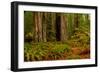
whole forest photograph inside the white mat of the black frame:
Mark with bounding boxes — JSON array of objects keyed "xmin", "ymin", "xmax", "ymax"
[{"xmin": 24, "ymin": 11, "xmax": 90, "ymax": 61}]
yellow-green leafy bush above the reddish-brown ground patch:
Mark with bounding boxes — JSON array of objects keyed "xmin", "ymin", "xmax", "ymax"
[{"xmin": 69, "ymin": 29, "xmax": 90, "ymax": 48}]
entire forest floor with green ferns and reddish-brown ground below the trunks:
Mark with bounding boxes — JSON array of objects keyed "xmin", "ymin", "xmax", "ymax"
[{"xmin": 24, "ymin": 42, "xmax": 90, "ymax": 61}]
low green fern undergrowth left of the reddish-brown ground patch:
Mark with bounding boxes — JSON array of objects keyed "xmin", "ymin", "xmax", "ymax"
[{"xmin": 24, "ymin": 42, "xmax": 70, "ymax": 61}]
